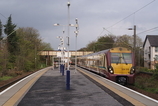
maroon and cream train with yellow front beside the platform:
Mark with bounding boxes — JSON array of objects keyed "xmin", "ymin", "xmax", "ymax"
[{"xmin": 78, "ymin": 47, "xmax": 135, "ymax": 85}]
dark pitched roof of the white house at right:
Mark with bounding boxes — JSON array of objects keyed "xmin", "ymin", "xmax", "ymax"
[{"xmin": 143, "ymin": 35, "xmax": 158, "ymax": 47}]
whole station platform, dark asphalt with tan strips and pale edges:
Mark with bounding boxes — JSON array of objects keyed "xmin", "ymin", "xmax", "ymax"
[{"xmin": 0, "ymin": 67, "xmax": 157, "ymax": 106}]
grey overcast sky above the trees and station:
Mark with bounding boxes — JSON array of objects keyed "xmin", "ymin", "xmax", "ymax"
[{"xmin": 0, "ymin": 0, "xmax": 158, "ymax": 50}]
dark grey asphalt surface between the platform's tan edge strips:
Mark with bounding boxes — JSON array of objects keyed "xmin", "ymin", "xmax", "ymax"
[{"xmin": 18, "ymin": 68, "xmax": 131, "ymax": 106}]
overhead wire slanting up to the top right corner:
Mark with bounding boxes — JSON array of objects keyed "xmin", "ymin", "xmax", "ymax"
[{"xmin": 106, "ymin": 0, "xmax": 155, "ymax": 29}]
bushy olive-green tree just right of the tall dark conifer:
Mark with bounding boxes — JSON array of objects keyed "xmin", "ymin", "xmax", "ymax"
[{"xmin": 16, "ymin": 27, "xmax": 52, "ymax": 71}]
